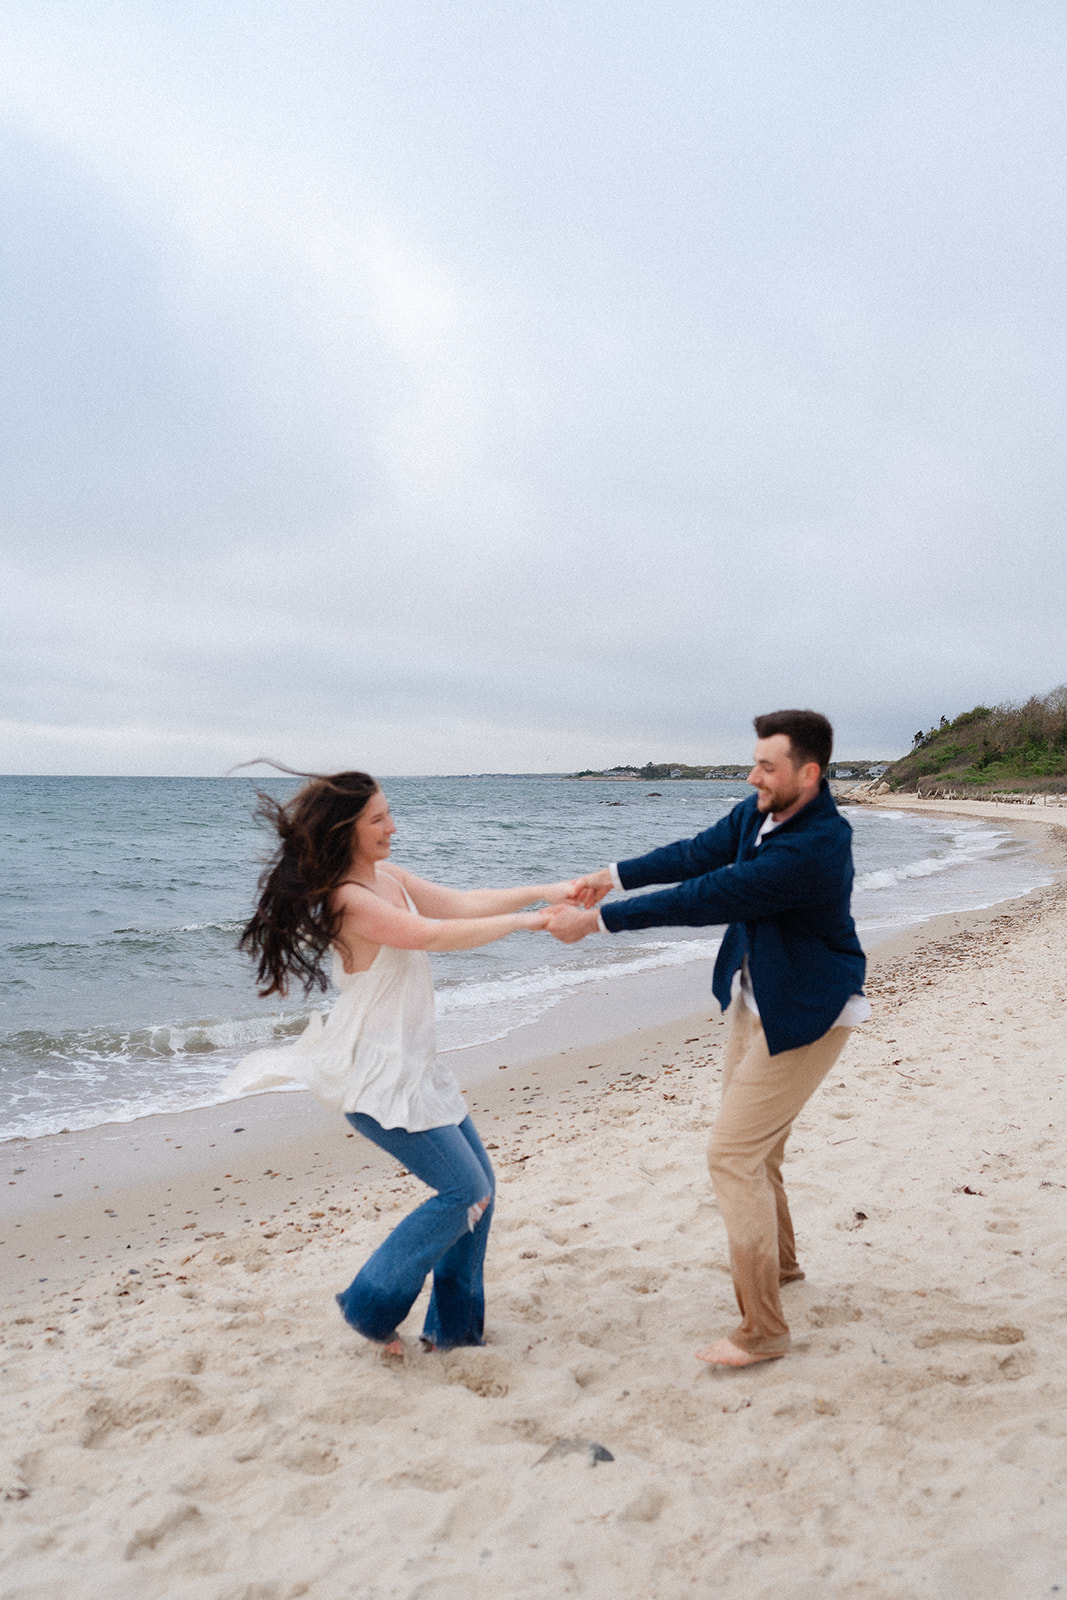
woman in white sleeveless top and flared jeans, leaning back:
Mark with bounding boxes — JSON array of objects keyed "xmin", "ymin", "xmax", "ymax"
[{"xmin": 227, "ymin": 773, "xmax": 573, "ymax": 1355}]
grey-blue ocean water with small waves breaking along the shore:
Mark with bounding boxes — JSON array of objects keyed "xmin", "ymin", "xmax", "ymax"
[{"xmin": 0, "ymin": 776, "xmax": 1051, "ymax": 1139}]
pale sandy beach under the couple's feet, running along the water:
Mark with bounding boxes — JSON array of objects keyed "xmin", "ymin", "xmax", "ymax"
[{"xmin": 0, "ymin": 798, "xmax": 1067, "ymax": 1600}]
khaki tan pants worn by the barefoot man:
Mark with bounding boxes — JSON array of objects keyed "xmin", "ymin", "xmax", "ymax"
[{"xmin": 707, "ymin": 995, "xmax": 851, "ymax": 1355}]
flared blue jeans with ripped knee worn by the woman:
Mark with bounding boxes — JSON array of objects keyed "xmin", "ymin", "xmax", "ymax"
[{"xmin": 338, "ymin": 1112, "xmax": 494, "ymax": 1350}]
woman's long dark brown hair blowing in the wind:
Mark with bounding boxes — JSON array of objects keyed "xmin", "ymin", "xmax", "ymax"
[{"xmin": 240, "ymin": 768, "xmax": 378, "ymax": 997}]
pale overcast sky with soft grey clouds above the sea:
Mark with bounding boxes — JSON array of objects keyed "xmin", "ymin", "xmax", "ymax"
[{"xmin": 0, "ymin": 0, "xmax": 1067, "ymax": 774}]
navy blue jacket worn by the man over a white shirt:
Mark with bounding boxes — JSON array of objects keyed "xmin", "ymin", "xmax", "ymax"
[{"xmin": 600, "ymin": 779, "xmax": 867, "ymax": 1056}]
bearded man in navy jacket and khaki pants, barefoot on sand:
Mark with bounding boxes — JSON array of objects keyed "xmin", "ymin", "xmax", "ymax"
[{"xmin": 549, "ymin": 710, "xmax": 870, "ymax": 1366}]
